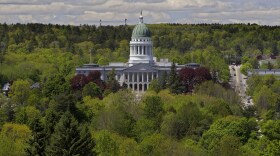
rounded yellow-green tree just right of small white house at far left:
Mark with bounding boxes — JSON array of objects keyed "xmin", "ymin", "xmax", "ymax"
[{"xmin": 11, "ymin": 80, "xmax": 30, "ymax": 105}]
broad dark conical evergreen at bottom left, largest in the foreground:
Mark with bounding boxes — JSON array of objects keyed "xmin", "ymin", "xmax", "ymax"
[{"xmin": 47, "ymin": 111, "xmax": 93, "ymax": 156}]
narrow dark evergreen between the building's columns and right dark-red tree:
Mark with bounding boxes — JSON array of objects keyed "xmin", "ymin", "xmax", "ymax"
[{"xmin": 168, "ymin": 62, "xmax": 180, "ymax": 94}]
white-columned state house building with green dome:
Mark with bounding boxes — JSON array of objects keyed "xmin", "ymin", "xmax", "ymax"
[{"xmin": 76, "ymin": 14, "xmax": 199, "ymax": 92}]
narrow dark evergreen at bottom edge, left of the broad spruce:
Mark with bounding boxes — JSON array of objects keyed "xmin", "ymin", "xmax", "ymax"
[{"xmin": 25, "ymin": 118, "xmax": 46, "ymax": 156}]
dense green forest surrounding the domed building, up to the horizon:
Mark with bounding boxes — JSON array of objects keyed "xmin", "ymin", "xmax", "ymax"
[{"xmin": 0, "ymin": 24, "xmax": 280, "ymax": 156}]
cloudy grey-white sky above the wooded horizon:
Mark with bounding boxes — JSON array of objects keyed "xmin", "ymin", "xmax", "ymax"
[{"xmin": 0, "ymin": 0, "xmax": 280, "ymax": 25}]
